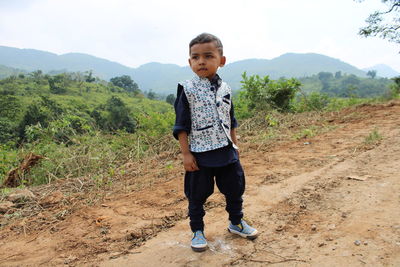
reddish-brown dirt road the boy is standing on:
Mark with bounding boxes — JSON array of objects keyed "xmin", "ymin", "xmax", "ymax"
[{"xmin": 0, "ymin": 102, "xmax": 400, "ymax": 266}]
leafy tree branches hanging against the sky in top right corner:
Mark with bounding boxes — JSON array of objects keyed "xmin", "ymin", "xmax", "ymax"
[{"xmin": 358, "ymin": 0, "xmax": 400, "ymax": 44}]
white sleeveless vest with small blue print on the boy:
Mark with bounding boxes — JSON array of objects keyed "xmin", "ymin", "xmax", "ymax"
[{"xmin": 181, "ymin": 76, "xmax": 237, "ymax": 152}]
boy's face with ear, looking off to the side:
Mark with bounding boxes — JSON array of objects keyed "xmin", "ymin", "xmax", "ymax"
[{"xmin": 189, "ymin": 42, "xmax": 226, "ymax": 79}]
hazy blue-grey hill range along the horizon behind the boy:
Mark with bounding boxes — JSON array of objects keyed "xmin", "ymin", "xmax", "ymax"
[{"xmin": 0, "ymin": 46, "xmax": 368, "ymax": 94}]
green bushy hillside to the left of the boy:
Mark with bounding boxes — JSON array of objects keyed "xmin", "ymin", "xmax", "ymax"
[{"xmin": 0, "ymin": 71, "xmax": 174, "ymax": 184}]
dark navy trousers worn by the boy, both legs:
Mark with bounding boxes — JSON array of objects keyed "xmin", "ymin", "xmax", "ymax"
[{"xmin": 185, "ymin": 161, "xmax": 245, "ymax": 232}]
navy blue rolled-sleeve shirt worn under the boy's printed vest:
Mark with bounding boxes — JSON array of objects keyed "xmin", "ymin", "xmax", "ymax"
[{"xmin": 173, "ymin": 74, "xmax": 239, "ymax": 167}]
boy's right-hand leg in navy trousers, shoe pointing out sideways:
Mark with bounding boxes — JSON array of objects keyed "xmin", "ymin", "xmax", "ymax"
[{"xmin": 216, "ymin": 161, "xmax": 246, "ymax": 224}]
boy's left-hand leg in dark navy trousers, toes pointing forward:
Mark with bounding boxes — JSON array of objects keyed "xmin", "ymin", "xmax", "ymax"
[{"xmin": 185, "ymin": 166, "xmax": 214, "ymax": 232}]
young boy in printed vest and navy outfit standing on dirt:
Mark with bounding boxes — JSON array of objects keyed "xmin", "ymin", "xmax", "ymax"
[{"xmin": 173, "ymin": 33, "xmax": 257, "ymax": 251}]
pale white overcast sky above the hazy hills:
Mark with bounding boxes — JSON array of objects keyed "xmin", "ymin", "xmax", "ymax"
[{"xmin": 0, "ymin": 0, "xmax": 400, "ymax": 72}]
